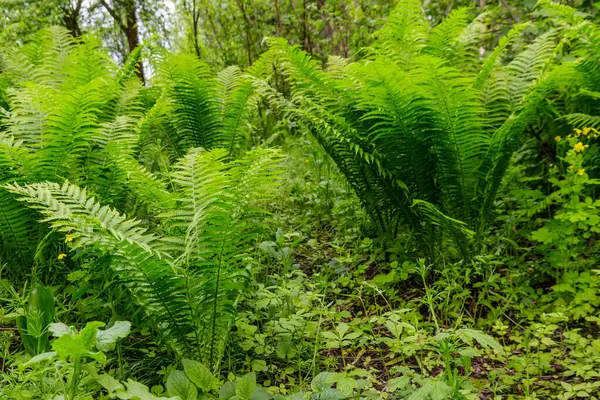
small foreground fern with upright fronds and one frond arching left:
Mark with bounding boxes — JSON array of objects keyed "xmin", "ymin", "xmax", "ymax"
[{"xmin": 6, "ymin": 149, "xmax": 280, "ymax": 368}]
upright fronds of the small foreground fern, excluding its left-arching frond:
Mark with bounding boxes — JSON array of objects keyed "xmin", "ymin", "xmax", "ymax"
[{"xmin": 164, "ymin": 149, "xmax": 280, "ymax": 366}]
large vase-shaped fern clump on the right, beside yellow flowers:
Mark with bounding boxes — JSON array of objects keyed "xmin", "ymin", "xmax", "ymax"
[{"xmin": 255, "ymin": 0, "xmax": 562, "ymax": 258}]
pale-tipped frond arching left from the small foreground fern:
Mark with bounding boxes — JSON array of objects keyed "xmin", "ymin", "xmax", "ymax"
[{"xmin": 5, "ymin": 182, "xmax": 193, "ymax": 350}]
